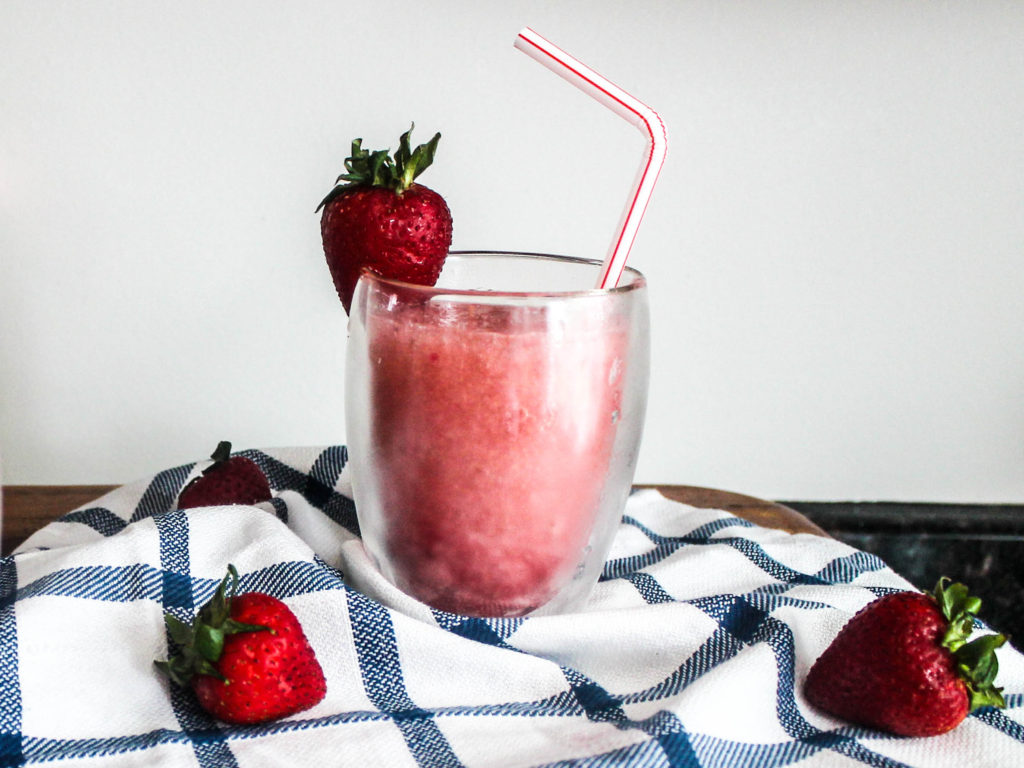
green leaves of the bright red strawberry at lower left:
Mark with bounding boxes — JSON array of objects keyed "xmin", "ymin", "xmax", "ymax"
[{"xmin": 154, "ymin": 565, "xmax": 272, "ymax": 685}]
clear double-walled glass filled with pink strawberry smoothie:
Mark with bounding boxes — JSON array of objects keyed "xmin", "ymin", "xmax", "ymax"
[{"xmin": 346, "ymin": 252, "xmax": 649, "ymax": 616}]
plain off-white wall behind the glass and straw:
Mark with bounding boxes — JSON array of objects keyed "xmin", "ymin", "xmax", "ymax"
[{"xmin": 0, "ymin": 0, "xmax": 1024, "ymax": 503}]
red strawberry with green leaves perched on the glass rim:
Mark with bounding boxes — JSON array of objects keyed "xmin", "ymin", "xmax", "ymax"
[{"xmin": 316, "ymin": 123, "xmax": 452, "ymax": 312}]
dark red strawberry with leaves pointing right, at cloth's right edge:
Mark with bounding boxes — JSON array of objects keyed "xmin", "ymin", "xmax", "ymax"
[{"xmin": 804, "ymin": 577, "xmax": 1007, "ymax": 736}]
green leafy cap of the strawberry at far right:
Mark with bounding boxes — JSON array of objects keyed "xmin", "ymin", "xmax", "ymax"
[{"xmin": 932, "ymin": 577, "xmax": 1007, "ymax": 712}]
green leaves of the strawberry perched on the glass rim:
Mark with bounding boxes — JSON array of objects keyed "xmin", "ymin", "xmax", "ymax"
[{"xmin": 316, "ymin": 123, "xmax": 441, "ymax": 211}]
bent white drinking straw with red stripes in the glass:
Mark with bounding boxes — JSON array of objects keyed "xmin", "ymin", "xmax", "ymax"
[{"xmin": 515, "ymin": 27, "xmax": 668, "ymax": 288}]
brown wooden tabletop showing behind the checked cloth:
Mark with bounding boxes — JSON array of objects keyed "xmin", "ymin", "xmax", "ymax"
[{"xmin": 0, "ymin": 485, "xmax": 827, "ymax": 555}]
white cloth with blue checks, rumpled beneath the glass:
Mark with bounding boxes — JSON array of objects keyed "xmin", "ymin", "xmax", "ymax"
[{"xmin": 0, "ymin": 446, "xmax": 1024, "ymax": 768}]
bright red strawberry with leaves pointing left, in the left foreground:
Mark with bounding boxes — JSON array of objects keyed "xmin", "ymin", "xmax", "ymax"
[{"xmin": 156, "ymin": 565, "xmax": 327, "ymax": 723}]
